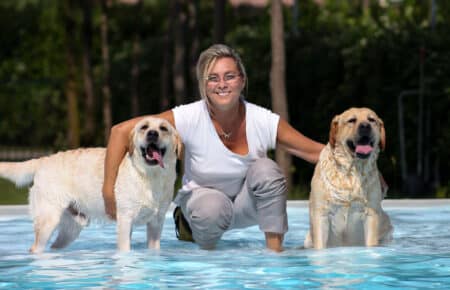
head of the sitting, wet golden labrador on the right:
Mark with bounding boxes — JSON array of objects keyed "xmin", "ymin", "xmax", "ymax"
[{"xmin": 329, "ymin": 108, "xmax": 386, "ymax": 159}]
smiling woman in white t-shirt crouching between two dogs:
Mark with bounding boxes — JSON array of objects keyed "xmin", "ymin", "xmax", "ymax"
[{"xmin": 103, "ymin": 44, "xmax": 323, "ymax": 251}]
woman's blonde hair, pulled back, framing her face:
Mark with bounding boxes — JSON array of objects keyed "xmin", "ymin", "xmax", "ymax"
[{"xmin": 197, "ymin": 44, "xmax": 247, "ymax": 106}]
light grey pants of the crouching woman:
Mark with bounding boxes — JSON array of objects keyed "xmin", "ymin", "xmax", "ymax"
[{"xmin": 177, "ymin": 158, "xmax": 288, "ymax": 249}]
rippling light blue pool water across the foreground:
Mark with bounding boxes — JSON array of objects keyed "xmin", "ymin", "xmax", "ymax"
[{"xmin": 0, "ymin": 206, "xmax": 450, "ymax": 289}]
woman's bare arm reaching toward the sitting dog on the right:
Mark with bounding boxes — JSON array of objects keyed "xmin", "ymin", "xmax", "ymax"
[{"xmin": 277, "ymin": 118, "xmax": 325, "ymax": 163}]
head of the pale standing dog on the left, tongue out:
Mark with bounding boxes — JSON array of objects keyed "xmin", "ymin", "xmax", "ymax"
[{"xmin": 128, "ymin": 117, "xmax": 183, "ymax": 168}]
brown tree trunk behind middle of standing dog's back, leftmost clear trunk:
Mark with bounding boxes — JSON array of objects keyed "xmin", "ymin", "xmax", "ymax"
[{"xmin": 63, "ymin": 0, "xmax": 80, "ymax": 148}]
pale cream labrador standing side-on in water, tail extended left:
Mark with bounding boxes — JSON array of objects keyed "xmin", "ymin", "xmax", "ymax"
[{"xmin": 0, "ymin": 117, "xmax": 182, "ymax": 253}]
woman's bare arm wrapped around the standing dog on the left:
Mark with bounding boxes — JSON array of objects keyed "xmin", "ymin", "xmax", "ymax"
[{"xmin": 102, "ymin": 110, "xmax": 175, "ymax": 220}]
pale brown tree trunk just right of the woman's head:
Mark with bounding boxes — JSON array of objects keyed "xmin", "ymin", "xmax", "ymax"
[{"xmin": 270, "ymin": 0, "xmax": 292, "ymax": 189}]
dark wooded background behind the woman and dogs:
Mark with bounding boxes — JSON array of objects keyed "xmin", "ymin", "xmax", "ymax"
[{"xmin": 0, "ymin": 0, "xmax": 450, "ymax": 204}]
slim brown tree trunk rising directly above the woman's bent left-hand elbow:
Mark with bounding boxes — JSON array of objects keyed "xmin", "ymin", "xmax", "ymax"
[{"xmin": 100, "ymin": 0, "xmax": 112, "ymax": 144}]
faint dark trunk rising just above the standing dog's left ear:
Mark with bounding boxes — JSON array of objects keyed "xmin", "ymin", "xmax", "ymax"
[{"xmin": 131, "ymin": 0, "xmax": 142, "ymax": 117}]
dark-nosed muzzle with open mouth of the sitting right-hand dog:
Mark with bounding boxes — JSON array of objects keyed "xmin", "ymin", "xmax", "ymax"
[{"xmin": 347, "ymin": 122, "xmax": 374, "ymax": 159}]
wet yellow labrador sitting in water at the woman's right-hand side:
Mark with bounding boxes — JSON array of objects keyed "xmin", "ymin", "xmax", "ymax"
[{"xmin": 304, "ymin": 108, "xmax": 392, "ymax": 249}]
